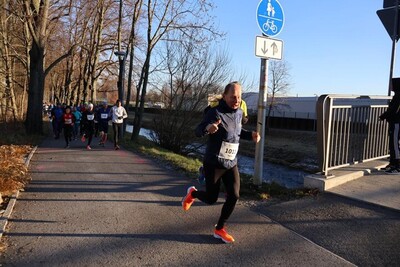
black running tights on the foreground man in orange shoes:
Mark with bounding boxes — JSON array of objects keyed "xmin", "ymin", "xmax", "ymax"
[{"xmin": 192, "ymin": 164, "xmax": 240, "ymax": 229}]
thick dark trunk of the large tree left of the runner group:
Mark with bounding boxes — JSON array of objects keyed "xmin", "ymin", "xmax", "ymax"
[{"xmin": 25, "ymin": 42, "xmax": 45, "ymax": 134}]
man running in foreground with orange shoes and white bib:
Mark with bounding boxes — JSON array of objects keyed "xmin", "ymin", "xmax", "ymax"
[{"xmin": 182, "ymin": 82, "xmax": 260, "ymax": 243}]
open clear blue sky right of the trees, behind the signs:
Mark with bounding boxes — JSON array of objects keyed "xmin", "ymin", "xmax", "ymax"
[{"xmin": 214, "ymin": 0, "xmax": 394, "ymax": 96}]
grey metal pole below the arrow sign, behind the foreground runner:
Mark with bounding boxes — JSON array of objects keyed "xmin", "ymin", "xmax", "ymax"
[{"xmin": 253, "ymin": 58, "xmax": 268, "ymax": 185}]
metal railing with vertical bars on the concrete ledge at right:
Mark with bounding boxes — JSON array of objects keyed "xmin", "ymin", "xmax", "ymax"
[{"xmin": 316, "ymin": 95, "xmax": 391, "ymax": 177}]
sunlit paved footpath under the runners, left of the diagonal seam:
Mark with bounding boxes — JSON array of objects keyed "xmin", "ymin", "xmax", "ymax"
[{"xmin": 0, "ymin": 139, "xmax": 352, "ymax": 266}]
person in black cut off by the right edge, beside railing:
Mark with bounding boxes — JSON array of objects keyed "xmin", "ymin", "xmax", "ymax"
[{"xmin": 379, "ymin": 78, "xmax": 400, "ymax": 174}]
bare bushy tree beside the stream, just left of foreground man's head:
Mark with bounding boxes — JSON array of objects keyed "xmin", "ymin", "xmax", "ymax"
[{"xmin": 154, "ymin": 34, "xmax": 230, "ymax": 153}]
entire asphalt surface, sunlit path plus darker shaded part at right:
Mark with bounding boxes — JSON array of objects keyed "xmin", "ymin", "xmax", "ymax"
[{"xmin": 0, "ymin": 139, "xmax": 400, "ymax": 266}]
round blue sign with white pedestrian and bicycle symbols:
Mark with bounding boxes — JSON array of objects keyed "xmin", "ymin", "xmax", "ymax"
[{"xmin": 257, "ymin": 0, "xmax": 285, "ymax": 37}]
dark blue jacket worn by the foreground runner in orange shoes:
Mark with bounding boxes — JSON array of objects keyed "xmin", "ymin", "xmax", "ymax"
[{"xmin": 196, "ymin": 100, "xmax": 252, "ymax": 169}]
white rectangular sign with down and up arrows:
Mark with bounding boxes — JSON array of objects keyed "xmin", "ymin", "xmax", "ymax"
[{"xmin": 256, "ymin": 36, "xmax": 283, "ymax": 59}]
